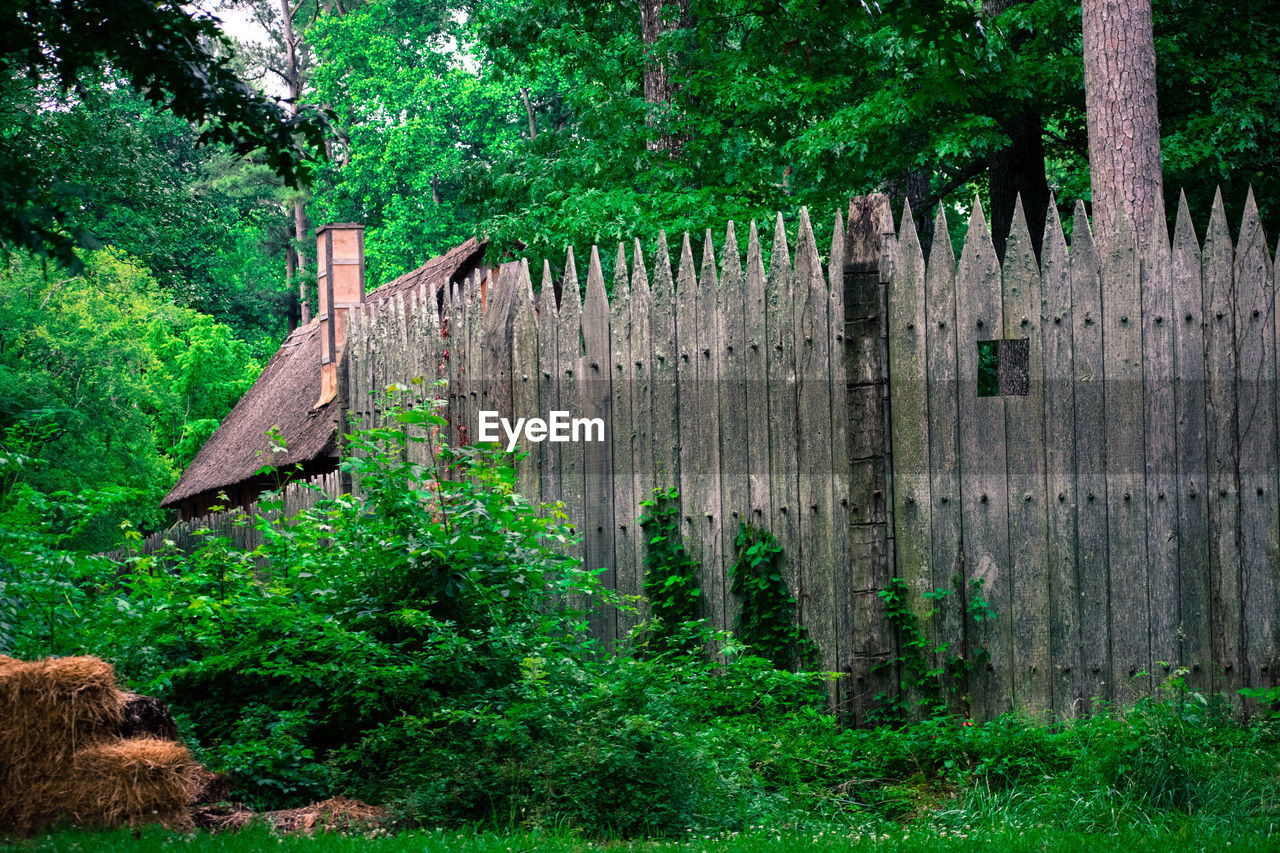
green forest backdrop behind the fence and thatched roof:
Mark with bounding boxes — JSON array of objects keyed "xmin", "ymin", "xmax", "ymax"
[{"xmin": 0, "ymin": 0, "xmax": 1280, "ymax": 546}]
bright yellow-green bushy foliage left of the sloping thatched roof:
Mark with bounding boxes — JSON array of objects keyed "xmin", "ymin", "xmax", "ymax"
[{"xmin": 0, "ymin": 251, "xmax": 260, "ymax": 547}]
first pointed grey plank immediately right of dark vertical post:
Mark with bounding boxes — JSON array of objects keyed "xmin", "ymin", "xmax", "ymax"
[{"xmin": 888, "ymin": 202, "xmax": 937, "ymax": 712}]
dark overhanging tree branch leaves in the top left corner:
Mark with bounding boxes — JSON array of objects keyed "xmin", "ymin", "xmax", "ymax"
[{"xmin": 0, "ymin": 0, "xmax": 326, "ymax": 272}]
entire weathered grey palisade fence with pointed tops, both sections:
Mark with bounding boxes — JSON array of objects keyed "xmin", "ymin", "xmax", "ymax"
[{"xmin": 343, "ymin": 185, "xmax": 1280, "ymax": 720}]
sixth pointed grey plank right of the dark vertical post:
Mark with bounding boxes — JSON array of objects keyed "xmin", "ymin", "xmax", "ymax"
[{"xmin": 1071, "ymin": 202, "xmax": 1111, "ymax": 707}]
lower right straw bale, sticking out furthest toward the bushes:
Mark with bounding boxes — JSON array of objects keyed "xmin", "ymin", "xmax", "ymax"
[{"xmin": 64, "ymin": 738, "xmax": 211, "ymax": 829}]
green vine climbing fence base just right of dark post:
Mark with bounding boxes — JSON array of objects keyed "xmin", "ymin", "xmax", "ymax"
[{"xmin": 877, "ymin": 578, "xmax": 997, "ymax": 719}]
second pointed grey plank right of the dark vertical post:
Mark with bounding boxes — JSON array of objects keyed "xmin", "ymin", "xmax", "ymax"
[{"xmin": 924, "ymin": 205, "xmax": 965, "ymax": 711}]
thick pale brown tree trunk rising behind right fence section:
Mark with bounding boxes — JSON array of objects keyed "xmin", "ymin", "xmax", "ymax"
[{"xmin": 1082, "ymin": 0, "xmax": 1165, "ymax": 247}]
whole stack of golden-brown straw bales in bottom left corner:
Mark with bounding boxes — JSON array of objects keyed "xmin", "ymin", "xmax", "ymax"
[{"xmin": 0, "ymin": 656, "xmax": 210, "ymax": 834}]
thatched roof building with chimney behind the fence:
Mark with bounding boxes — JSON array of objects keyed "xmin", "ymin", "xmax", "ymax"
[{"xmin": 161, "ymin": 224, "xmax": 485, "ymax": 519}]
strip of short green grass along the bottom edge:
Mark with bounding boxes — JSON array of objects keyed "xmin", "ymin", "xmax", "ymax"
[{"xmin": 13, "ymin": 827, "xmax": 1280, "ymax": 853}]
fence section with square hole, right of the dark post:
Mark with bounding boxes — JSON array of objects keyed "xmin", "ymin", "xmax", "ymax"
[{"xmin": 888, "ymin": 188, "xmax": 1280, "ymax": 716}]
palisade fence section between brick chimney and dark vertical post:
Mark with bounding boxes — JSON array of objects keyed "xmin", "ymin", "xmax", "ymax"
[{"xmin": 344, "ymin": 204, "xmax": 892, "ymax": 707}]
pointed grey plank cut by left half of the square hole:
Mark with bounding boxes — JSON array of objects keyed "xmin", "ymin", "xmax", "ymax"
[{"xmin": 962, "ymin": 202, "xmax": 1012, "ymax": 717}]
